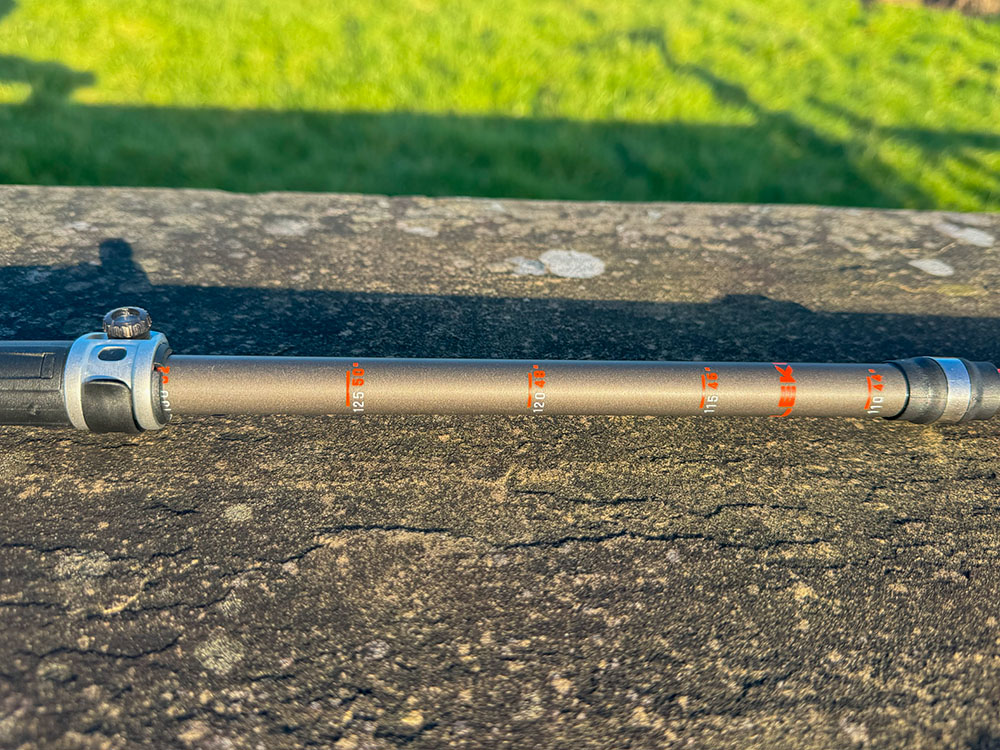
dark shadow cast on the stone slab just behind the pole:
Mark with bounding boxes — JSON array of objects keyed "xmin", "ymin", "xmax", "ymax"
[{"xmin": 0, "ymin": 238, "xmax": 997, "ymax": 362}]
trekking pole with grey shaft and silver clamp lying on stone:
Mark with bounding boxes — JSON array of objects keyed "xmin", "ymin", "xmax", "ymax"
[{"xmin": 0, "ymin": 307, "xmax": 1000, "ymax": 433}]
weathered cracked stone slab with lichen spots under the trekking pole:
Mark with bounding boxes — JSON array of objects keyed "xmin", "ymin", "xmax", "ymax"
[{"xmin": 0, "ymin": 187, "xmax": 1000, "ymax": 750}]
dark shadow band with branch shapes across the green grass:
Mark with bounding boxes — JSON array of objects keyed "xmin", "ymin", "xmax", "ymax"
[{"xmin": 0, "ymin": 0, "xmax": 1000, "ymax": 208}]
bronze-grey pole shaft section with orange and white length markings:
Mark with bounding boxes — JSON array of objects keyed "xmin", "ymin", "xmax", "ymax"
[{"xmin": 165, "ymin": 355, "xmax": 908, "ymax": 417}]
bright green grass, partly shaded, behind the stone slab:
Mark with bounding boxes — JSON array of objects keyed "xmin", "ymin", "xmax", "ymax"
[{"xmin": 0, "ymin": 0, "xmax": 1000, "ymax": 210}]
